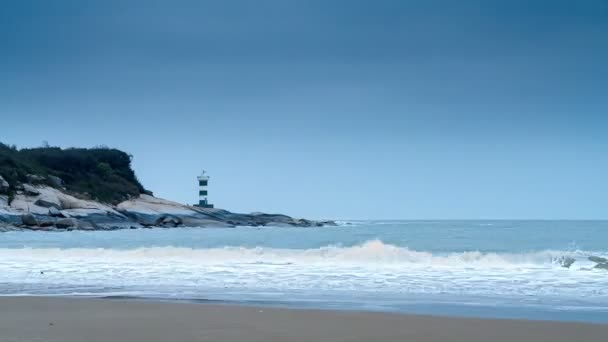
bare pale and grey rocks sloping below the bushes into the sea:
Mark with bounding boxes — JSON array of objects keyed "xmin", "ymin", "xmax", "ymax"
[{"xmin": 0, "ymin": 184, "xmax": 335, "ymax": 231}]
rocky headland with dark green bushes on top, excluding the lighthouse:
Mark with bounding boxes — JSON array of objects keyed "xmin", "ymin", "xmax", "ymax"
[{"xmin": 0, "ymin": 144, "xmax": 335, "ymax": 232}]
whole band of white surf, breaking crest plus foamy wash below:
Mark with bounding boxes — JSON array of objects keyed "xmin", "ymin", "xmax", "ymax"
[{"xmin": 0, "ymin": 240, "xmax": 608, "ymax": 305}]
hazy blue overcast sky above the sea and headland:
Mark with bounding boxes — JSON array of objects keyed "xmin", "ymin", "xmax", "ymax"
[{"xmin": 0, "ymin": 0, "xmax": 608, "ymax": 219}]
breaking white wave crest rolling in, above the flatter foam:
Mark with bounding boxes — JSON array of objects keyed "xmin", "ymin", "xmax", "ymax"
[{"xmin": 0, "ymin": 240, "xmax": 606, "ymax": 268}]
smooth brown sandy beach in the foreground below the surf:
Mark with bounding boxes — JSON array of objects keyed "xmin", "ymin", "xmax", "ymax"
[{"xmin": 0, "ymin": 297, "xmax": 608, "ymax": 342}]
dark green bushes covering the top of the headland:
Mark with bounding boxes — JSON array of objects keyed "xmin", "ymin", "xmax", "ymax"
[{"xmin": 0, "ymin": 143, "xmax": 146, "ymax": 204}]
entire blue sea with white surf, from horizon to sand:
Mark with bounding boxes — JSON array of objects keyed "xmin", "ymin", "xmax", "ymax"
[{"xmin": 0, "ymin": 221, "xmax": 608, "ymax": 322}]
